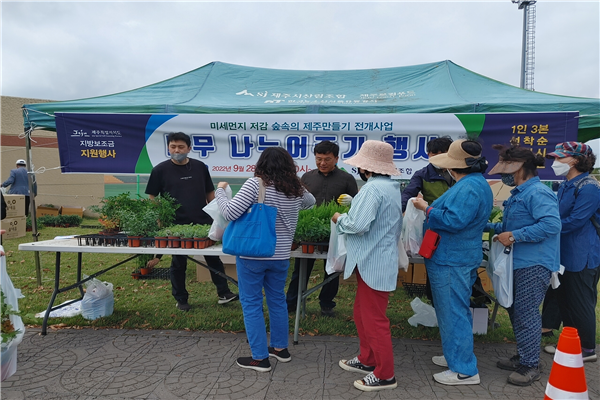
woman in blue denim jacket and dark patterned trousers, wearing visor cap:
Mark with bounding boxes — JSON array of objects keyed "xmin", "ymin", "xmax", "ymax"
[{"xmin": 486, "ymin": 145, "xmax": 561, "ymax": 386}]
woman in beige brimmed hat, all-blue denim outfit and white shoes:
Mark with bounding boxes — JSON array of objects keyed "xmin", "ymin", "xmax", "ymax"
[{"xmin": 414, "ymin": 139, "xmax": 493, "ymax": 386}]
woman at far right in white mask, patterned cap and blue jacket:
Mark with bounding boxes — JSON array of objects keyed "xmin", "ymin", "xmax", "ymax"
[{"xmin": 547, "ymin": 142, "xmax": 600, "ymax": 362}]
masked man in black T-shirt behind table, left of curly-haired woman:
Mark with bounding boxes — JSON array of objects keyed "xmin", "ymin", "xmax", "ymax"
[{"xmin": 146, "ymin": 132, "xmax": 238, "ymax": 311}]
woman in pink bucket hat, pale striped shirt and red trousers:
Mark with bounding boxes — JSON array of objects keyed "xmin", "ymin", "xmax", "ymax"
[{"xmin": 332, "ymin": 140, "xmax": 402, "ymax": 391}]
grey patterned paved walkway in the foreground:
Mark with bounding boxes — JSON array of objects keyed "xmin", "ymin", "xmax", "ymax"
[{"xmin": 1, "ymin": 328, "xmax": 600, "ymax": 400}]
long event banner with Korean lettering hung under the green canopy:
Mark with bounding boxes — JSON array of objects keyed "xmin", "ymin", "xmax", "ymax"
[{"xmin": 55, "ymin": 112, "xmax": 578, "ymax": 180}]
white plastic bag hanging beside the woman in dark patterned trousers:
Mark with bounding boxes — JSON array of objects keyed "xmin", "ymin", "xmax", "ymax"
[{"xmin": 488, "ymin": 240, "xmax": 513, "ymax": 307}]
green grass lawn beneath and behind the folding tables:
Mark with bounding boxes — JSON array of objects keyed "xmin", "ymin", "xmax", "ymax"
[{"xmin": 3, "ymin": 219, "xmax": 600, "ymax": 344}]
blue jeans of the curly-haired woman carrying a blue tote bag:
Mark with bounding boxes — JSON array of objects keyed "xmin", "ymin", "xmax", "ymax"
[{"xmin": 236, "ymin": 257, "xmax": 290, "ymax": 360}]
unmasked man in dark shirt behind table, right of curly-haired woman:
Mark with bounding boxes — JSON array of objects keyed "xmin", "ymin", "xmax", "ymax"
[{"xmin": 286, "ymin": 140, "xmax": 358, "ymax": 317}]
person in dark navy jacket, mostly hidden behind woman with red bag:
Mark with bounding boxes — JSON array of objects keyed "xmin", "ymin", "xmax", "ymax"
[{"xmin": 402, "ymin": 136, "xmax": 456, "ymax": 213}]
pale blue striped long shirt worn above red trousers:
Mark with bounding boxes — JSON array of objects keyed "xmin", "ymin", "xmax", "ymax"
[{"xmin": 336, "ymin": 177, "xmax": 402, "ymax": 292}]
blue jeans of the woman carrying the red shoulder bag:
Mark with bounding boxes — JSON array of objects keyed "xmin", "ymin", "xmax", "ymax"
[{"xmin": 425, "ymin": 260, "xmax": 479, "ymax": 376}]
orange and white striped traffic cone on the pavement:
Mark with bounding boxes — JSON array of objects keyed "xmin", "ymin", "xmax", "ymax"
[{"xmin": 544, "ymin": 327, "xmax": 589, "ymax": 400}]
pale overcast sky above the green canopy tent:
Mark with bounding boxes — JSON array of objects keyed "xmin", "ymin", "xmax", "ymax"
[{"xmin": 1, "ymin": 0, "xmax": 600, "ymax": 150}]
